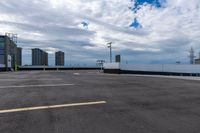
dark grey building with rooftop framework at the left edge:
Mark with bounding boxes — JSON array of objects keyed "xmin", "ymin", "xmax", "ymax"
[{"xmin": 0, "ymin": 35, "xmax": 21, "ymax": 71}]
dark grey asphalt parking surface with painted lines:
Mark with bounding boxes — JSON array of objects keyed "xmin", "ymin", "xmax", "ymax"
[{"xmin": 0, "ymin": 70, "xmax": 200, "ymax": 133}]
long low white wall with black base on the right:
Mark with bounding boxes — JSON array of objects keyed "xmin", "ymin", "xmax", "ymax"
[{"xmin": 104, "ymin": 63, "xmax": 200, "ymax": 76}]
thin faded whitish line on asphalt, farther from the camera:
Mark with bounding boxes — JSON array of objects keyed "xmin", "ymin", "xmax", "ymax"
[{"xmin": 0, "ymin": 84, "xmax": 74, "ymax": 89}]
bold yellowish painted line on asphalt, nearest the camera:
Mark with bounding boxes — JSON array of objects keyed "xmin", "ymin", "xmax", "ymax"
[{"xmin": 0, "ymin": 101, "xmax": 106, "ymax": 114}]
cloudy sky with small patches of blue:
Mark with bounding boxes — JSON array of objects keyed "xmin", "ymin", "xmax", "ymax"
[{"xmin": 0, "ymin": 0, "xmax": 200, "ymax": 65}]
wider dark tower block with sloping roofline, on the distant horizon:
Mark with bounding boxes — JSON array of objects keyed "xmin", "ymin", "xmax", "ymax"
[{"xmin": 32, "ymin": 48, "xmax": 48, "ymax": 66}]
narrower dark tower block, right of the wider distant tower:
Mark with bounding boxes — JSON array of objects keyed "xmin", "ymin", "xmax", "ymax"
[{"xmin": 55, "ymin": 51, "xmax": 65, "ymax": 66}]
